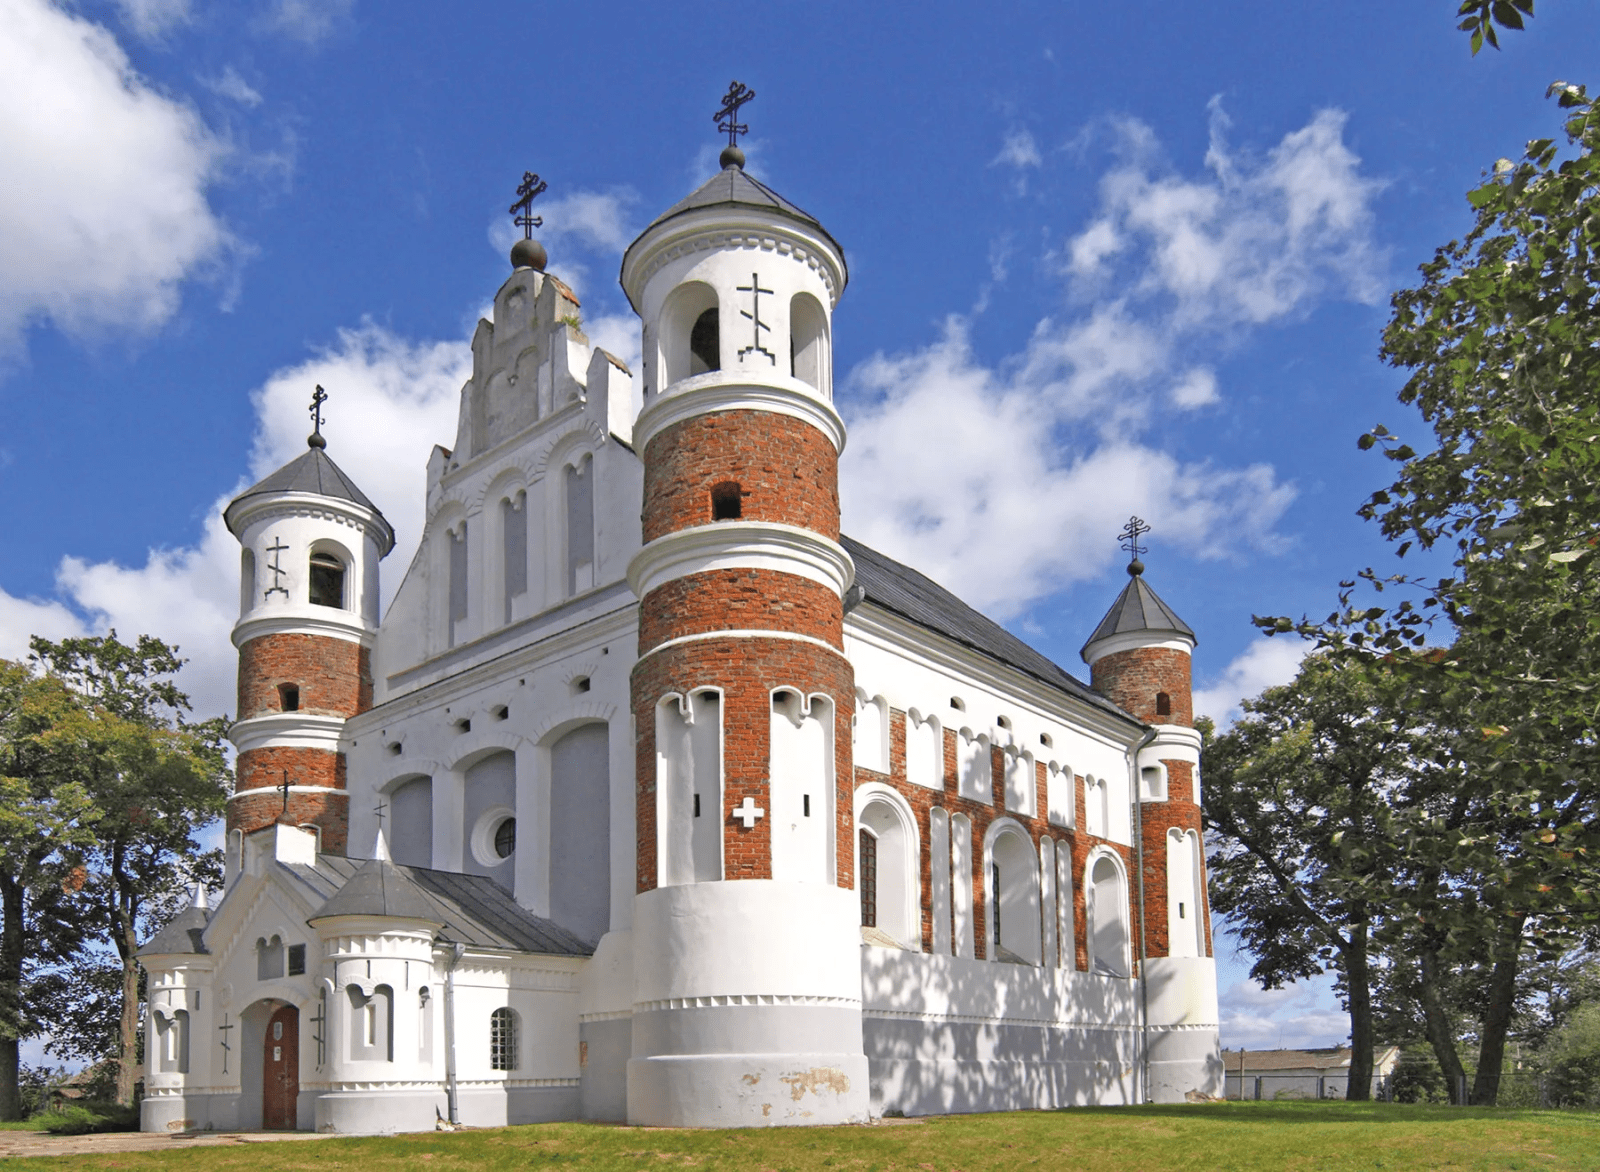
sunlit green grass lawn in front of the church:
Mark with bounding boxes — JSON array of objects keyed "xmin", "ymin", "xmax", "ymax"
[{"xmin": 6, "ymin": 1103, "xmax": 1600, "ymax": 1172}]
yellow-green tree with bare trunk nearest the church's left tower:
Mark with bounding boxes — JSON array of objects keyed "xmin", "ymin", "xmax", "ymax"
[{"xmin": 32, "ymin": 631, "xmax": 230, "ymax": 1105}]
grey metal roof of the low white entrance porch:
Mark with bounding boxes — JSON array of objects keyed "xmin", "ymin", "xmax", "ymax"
[{"xmin": 283, "ymin": 855, "xmax": 595, "ymax": 956}]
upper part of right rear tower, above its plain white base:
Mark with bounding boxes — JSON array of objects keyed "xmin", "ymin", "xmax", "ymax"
[{"xmin": 1083, "ymin": 541, "xmax": 1211, "ymax": 957}]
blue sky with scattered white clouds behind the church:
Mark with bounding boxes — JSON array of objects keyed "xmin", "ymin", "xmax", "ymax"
[{"xmin": 0, "ymin": 0, "xmax": 1600, "ymax": 1063}]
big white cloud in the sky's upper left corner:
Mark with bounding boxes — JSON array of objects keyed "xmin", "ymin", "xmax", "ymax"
[{"xmin": 0, "ymin": 0, "xmax": 230, "ymax": 352}]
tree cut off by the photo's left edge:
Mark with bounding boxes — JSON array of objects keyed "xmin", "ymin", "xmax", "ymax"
[{"xmin": 0, "ymin": 660, "xmax": 93, "ymax": 1119}]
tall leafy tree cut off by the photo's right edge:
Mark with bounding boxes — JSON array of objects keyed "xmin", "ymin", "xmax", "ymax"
[{"xmin": 1256, "ymin": 83, "xmax": 1600, "ymax": 1103}]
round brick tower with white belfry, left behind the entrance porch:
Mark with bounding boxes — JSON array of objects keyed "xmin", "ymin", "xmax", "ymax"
[{"xmin": 222, "ymin": 427, "xmax": 395, "ymax": 879}]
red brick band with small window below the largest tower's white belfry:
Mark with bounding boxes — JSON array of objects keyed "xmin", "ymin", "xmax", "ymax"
[{"xmin": 643, "ymin": 411, "xmax": 838, "ymax": 543}]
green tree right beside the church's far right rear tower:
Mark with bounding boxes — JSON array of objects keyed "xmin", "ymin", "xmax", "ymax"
[{"xmin": 1200, "ymin": 655, "xmax": 1451, "ymax": 1100}]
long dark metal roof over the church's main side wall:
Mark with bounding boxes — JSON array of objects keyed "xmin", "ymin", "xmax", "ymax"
[{"xmin": 840, "ymin": 536, "xmax": 1133, "ymax": 720}]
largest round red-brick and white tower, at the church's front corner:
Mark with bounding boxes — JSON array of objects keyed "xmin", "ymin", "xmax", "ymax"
[{"xmin": 622, "ymin": 152, "xmax": 869, "ymax": 1126}]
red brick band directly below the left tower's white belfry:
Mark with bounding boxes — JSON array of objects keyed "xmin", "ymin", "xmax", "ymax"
[{"xmin": 238, "ymin": 634, "xmax": 373, "ymax": 720}]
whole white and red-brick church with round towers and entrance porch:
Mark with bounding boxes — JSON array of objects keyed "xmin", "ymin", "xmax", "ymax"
[{"xmin": 141, "ymin": 86, "xmax": 1222, "ymax": 1132}]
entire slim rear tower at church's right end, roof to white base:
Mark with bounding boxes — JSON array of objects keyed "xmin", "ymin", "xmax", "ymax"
[{"xmin": 1083, "ymin": 559, "xmax": 1221, "ymax": 1102}]
